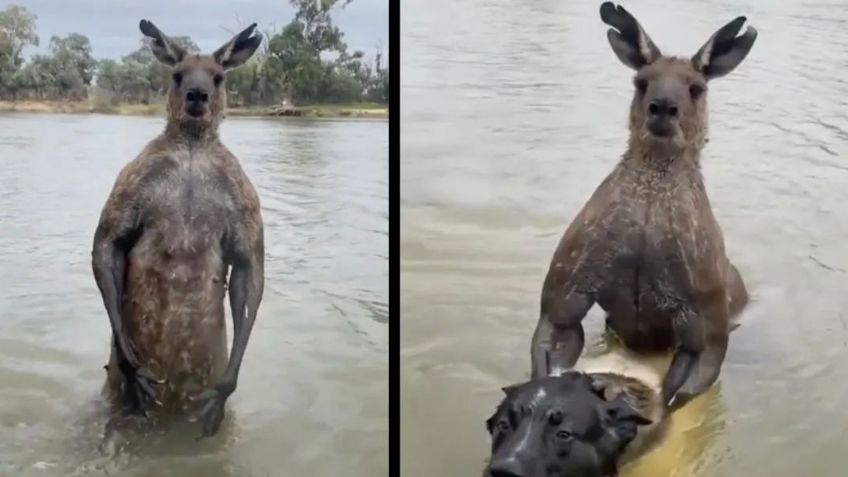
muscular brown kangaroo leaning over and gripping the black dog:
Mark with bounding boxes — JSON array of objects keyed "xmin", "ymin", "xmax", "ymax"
[{"xmin": 531, "ymin": 2, "xmax": 757, "ymax": 407}]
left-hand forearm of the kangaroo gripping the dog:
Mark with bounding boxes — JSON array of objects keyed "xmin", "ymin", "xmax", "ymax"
[{"xmin": 530, "ymin": 290, "xmax": 594, "ymax": 378}]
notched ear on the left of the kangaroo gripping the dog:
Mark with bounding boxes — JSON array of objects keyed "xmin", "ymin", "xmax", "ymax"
[{"xmin": 601, "ymin": 2, "xmax": 662, "ymax": 70}]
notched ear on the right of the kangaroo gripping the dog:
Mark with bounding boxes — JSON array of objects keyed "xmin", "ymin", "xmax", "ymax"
[{"xmin": 692, "ymin": 17, "xmax": 757, "ymax": 80}]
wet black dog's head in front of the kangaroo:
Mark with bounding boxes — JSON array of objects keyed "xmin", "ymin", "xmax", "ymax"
[{"xmin": 484, "ymin": 372, "xmax": 651, "ymax": 477}]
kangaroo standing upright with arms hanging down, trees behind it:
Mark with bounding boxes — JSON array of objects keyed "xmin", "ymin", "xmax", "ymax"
[{"xmin": 92, "ymin": 20, "xmax": 265, "ymax": 437}]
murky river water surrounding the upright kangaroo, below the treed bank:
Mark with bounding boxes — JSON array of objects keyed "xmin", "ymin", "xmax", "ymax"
[{"xmin": 0, "ymin": 114, "xmax": 388, "ymax": 477}]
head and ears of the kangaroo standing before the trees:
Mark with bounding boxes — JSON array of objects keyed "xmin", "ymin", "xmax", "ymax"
[{"xmin": 139, "ymin": 20, "xmax": 262, "ymax": 134}]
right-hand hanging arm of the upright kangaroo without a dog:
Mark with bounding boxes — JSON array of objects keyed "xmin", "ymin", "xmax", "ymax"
[{"xmin": 199, "ymin": 240, "xmax": 265, "ymax": 437}]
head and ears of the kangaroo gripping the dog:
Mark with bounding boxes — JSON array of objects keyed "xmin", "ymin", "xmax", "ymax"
[{"xmin": 601, "ymin": 2, "xmax": 757, "ymax": 151}]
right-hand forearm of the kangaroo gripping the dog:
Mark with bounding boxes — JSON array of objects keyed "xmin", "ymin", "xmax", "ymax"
[{"xmin": 662, "ymin": 294, "xmax": 729, "ymax": 408}]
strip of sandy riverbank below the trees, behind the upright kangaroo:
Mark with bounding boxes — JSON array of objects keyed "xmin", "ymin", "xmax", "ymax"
[{"xmin": 0, "ymin": 101, "xmax": 389, "ymax": 119}]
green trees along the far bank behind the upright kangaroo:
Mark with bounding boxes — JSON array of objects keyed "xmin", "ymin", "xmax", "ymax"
[{"xmin": 0, "ymin": 0, "xmax": 389, "ymax": 106}]
